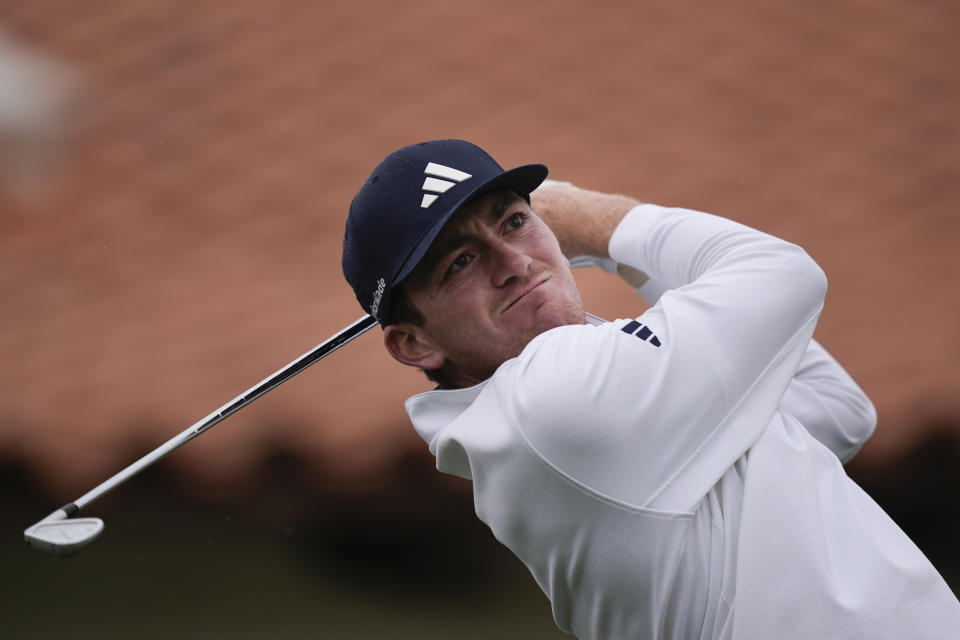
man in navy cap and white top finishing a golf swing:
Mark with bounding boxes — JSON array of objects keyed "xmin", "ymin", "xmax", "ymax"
[{"xmin": 343, "ymin": 140, "xmax": 960, "ymax": 640}]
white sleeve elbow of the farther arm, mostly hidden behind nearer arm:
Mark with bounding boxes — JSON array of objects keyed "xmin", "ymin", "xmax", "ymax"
[{"xmin": 781, "ymin": 340, "xmax": 877, "ymax": 463}]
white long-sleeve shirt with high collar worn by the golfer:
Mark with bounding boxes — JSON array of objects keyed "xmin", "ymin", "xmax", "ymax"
[{"xmin": 407, "ymin": 205, "xmax": 960, "ymax": 639}]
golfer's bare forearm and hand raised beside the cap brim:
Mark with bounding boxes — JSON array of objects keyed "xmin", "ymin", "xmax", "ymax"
[{"xmin": 530, "ymin": 180, "xmax": 640, "ymax": 258}]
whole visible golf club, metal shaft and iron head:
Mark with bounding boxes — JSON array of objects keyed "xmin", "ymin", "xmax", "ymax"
[{"xmin": 23, "ymin": 315, "xmax": 377, "ymax": 556}]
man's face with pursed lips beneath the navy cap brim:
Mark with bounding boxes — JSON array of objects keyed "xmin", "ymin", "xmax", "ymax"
[{"xmin": 390, "ymin": 191, "xmax": 584, "ymax": 386}]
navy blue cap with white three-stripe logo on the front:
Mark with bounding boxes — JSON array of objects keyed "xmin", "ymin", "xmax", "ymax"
[{"xmin": 342, "ymin": 140, "xmax": 547, "ymax": 325}]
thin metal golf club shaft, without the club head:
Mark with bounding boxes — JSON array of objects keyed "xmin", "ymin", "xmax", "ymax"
[{"xmin": 64, "ymin": 315, "xmax": 377, "ymax": 517}]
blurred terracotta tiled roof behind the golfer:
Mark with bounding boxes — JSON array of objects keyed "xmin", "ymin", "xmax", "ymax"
[{"xmin": 0, "ymin": 0, "xmax": 960, "ymax": 498}]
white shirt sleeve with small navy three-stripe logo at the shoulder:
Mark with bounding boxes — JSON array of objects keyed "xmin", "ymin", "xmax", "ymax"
[{"xmin": 511, "ymin": 205, "xmax": 826, "ymax": 511}]
